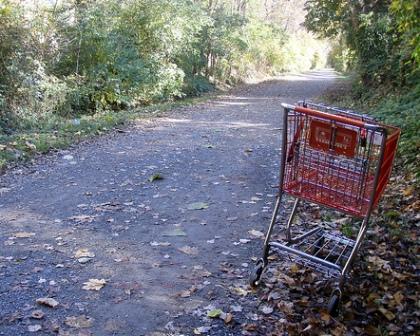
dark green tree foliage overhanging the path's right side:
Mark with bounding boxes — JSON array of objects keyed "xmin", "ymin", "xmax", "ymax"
[{"xmin": 305, "ymin": 0, "xmax": 420, "ymax": 87}]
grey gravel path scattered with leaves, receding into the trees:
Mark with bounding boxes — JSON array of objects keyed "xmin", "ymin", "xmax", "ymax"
[{"xmin": 0, "ymin": 71, "xmax": 336, "ymax": 335}]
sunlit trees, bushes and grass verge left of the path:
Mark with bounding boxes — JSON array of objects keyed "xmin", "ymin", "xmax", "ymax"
[{"xmin": 0, "ymin": 0, "xmax": 328, "ymax": 169}]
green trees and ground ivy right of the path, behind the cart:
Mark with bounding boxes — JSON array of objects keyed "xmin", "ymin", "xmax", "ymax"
[{"xmin": 305, "ymin": 0, "xmax": 420, "ymax": 180}]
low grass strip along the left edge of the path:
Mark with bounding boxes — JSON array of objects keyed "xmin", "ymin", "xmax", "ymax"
[{"xmin": 0, "ymin": 96, "xmax": 210, "ymax": 172}]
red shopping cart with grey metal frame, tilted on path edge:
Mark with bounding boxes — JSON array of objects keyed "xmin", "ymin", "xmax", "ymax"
[{"xmin": 250, "ymin": 102, "xmax": 400, "ymax": 315}]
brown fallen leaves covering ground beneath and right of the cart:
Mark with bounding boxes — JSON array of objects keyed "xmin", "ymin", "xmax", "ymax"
[{"xmin": 248, "ymin": 168, "xmax": 420, "ymax": 336}]
